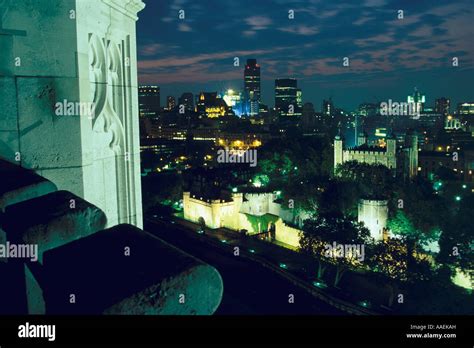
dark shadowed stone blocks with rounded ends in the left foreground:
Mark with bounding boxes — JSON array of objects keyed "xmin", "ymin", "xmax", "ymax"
[{"xmin": 0, "ymin": 160, "xmax": 223, "ymax": 315}]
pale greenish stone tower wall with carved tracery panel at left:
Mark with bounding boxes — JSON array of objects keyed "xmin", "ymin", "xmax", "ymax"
[{"xmin": 0, "ymin": 0, "xmax": 144, "ymax": 227}]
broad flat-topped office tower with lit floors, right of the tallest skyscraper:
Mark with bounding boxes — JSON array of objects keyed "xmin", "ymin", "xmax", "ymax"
[{"xmin": 275, "ymin": 79, "xmax": 301, "ymax": 116}]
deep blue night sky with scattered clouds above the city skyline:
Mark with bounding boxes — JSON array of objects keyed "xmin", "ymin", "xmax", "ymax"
[{"xmin": 137, "ymin": 0, "xmax": 474, "ymax": 110}]
